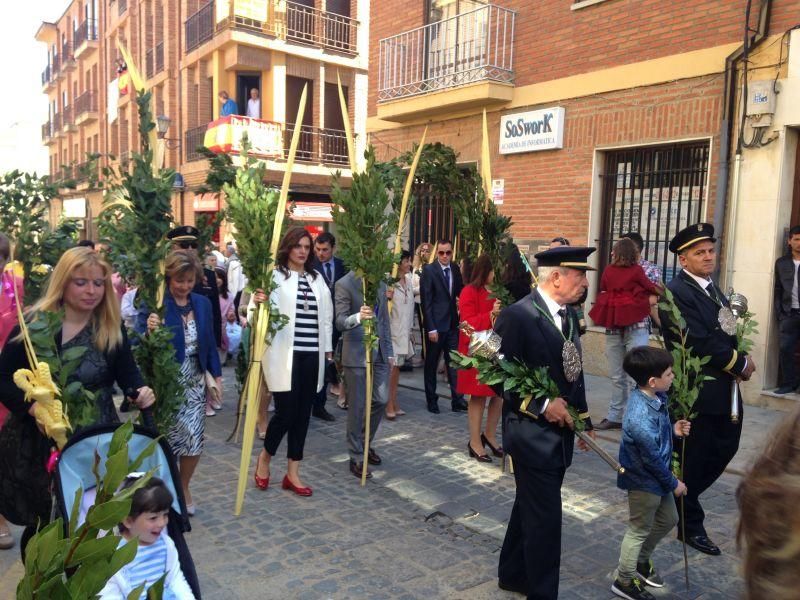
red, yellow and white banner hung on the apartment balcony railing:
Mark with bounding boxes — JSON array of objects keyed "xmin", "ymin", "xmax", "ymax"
[{"xmin": 203, "ymin": 115, "xmax": 283, "ymax": 158}]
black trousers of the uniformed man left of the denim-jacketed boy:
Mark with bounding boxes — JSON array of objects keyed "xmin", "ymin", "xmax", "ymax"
[{"xmin": 497, "ymin": 462, "xmax": 566, "ymax": 600}]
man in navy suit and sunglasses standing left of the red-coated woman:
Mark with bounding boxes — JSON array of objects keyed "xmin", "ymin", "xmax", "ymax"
[{"xmin": 419, "ymin": 240, "xmax": 467, "ymax": 413}]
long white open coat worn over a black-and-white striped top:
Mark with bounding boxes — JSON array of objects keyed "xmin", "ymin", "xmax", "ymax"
[{"xmin": 261, "ymin": 269, "xmax": 333, "ymax": 392}]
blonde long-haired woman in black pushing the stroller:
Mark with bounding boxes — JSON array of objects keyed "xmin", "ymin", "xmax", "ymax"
[{"xmin": 0, "ymin": 247, "xmax": 154, "ymax": 557}]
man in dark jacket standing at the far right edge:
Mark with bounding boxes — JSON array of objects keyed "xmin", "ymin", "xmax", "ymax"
[{"xmin": 774, "ymin": 225, "xmax": 800, "ymax": 394}]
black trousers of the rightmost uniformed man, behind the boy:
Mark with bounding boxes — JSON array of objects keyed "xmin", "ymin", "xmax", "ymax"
[{"xmin": 676, "ymin": 415, "xmax": 742, "ymax": 537}]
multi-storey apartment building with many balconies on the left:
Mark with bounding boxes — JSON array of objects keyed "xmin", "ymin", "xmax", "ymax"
[{"xmin": 37, "ymin": 0, "xmax": 362, "ymax": 238}]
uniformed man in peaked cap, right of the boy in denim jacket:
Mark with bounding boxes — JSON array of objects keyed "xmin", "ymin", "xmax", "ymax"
[{"xmin": 659, "ymin": 223, "xmax": 756, "ymax": 556}]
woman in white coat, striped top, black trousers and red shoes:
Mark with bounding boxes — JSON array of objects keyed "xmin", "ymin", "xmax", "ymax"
[{"xmin": 253, "ymin": 227, "xmax": 333, "ymax": 496}]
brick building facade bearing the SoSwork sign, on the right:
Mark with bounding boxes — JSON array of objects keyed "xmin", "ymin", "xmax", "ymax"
[{"xmin": 367, "ymin": 0, "xmax": 800, "ymax": 402}]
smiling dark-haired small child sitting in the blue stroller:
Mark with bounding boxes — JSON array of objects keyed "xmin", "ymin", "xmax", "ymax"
[{"xmin": 100, "ymin": 473, "xmax": 195, "ymax": 600}]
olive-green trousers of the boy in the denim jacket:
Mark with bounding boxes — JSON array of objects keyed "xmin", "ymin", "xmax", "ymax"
[{"xmin": 614, "ymin": 490, "xmax": 678, "ymax": 583}]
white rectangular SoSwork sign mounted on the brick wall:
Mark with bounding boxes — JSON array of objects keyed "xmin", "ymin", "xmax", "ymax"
[{"xmin": 500, "ymin": 106, "xmax": 564, "ymax": 154}]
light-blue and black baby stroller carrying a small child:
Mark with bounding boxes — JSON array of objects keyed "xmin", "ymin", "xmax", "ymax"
[{"xmin": 53, "ymin": 424, "xmax": 200, "ymax": 600}]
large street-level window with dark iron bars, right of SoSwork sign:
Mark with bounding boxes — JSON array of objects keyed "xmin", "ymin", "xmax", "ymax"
[{"xmin": 598, "ymin": 141, "xmax": 709, "ymax": 282}]
